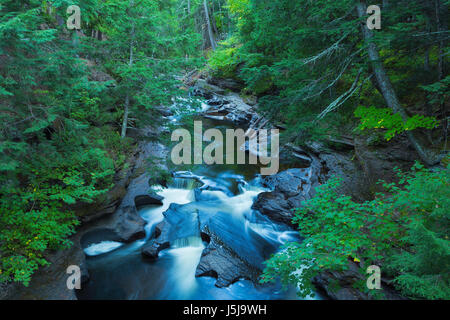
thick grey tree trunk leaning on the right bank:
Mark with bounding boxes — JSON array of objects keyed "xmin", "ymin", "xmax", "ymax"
[{"xmin": 357, "ymin": 1, "xmax": 439, "ymax": 166}]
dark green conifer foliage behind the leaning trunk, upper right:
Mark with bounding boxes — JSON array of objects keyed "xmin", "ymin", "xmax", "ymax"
[{"xmin": 209, "ymin": 0, "xmax": 449, "ymax": 148}]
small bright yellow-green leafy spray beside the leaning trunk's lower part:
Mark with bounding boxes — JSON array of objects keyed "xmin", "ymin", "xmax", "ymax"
[{"xmin": 355, "ymin": 106, "xmax": 439, "ymax": 141}]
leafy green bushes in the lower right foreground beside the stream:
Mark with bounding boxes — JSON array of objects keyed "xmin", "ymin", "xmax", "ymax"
[{"xmin": 262, "ymin": 165, "xmax": 450, "ymax": 299}]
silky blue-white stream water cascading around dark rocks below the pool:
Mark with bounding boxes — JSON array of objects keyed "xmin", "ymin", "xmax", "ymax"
[{"xmin": 78, "ymin": 117, "xmax": 324, "ymax": 300}]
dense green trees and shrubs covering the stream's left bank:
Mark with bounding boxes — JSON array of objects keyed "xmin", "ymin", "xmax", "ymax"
[{"xmin": 0, "ymin": 0, "xmax": 200, "ymax": 285}]
